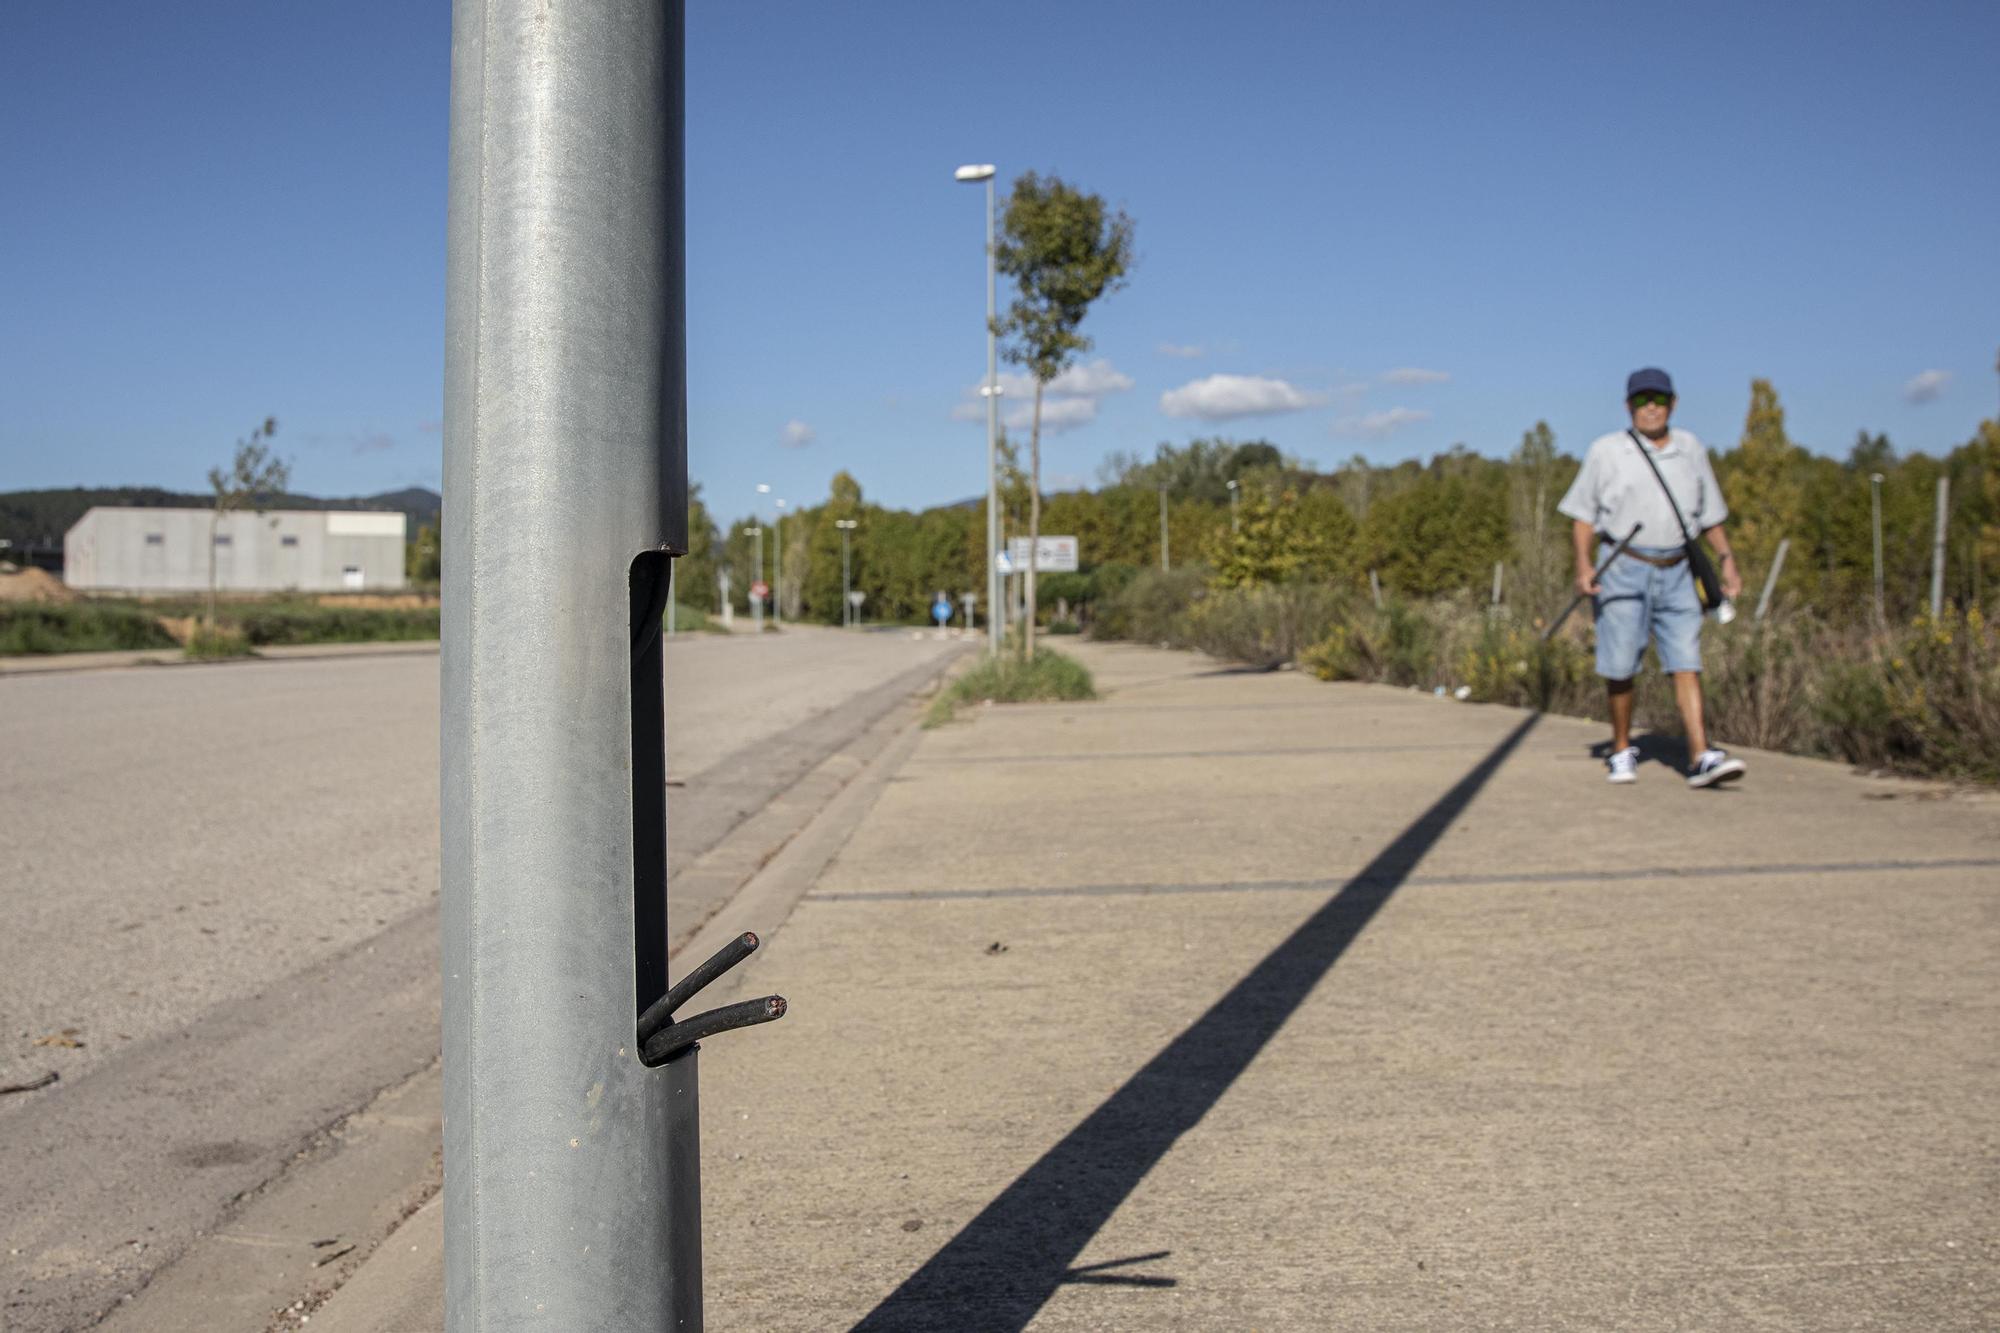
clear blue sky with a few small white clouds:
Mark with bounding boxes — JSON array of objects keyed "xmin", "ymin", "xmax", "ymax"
[{"xmin": 0, "ymin": 0, "xmax": 2000, "ymax": 518}]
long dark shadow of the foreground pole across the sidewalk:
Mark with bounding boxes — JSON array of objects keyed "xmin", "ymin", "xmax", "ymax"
[{"xmin": 854, "ymin": 715, "xmax": 1540, "ymax": 1333}]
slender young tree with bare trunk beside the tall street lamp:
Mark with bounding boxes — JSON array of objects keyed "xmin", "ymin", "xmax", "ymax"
[{"xmin": 994, "ymin": 172, "xmax": 1132, "ymax": 658}]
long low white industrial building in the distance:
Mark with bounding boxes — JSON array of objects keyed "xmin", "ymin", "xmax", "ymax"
[{"xmin": 62, "ymin": 506, "xmax": 408, "ymax": 592}]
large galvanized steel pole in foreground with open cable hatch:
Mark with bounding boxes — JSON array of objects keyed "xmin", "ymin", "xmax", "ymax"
[{"xmin": 442, "ymin": 0, "xmax": 700, "ymax": 1333}]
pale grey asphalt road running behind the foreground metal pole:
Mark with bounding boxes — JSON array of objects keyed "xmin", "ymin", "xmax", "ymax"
[{"xmin": 0, "ymin": 630, "xmax": 956, "ymax": 1329}]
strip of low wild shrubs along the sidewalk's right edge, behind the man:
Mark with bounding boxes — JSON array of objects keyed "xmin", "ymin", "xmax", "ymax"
[{"xmin": 1094, "ymin": 570, "xmax": 2000, "ymax": 783}]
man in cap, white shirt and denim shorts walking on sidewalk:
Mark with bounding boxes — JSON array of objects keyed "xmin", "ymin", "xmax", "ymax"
[{"xmin": 1556, "ymin": 366, "xmax": 1744, "ymax": 787}]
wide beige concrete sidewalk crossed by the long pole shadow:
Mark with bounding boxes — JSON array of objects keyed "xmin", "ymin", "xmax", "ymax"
[{"xmin": 312, "ymin": 644, "xmax": 2000, "ymax": 1331}]
